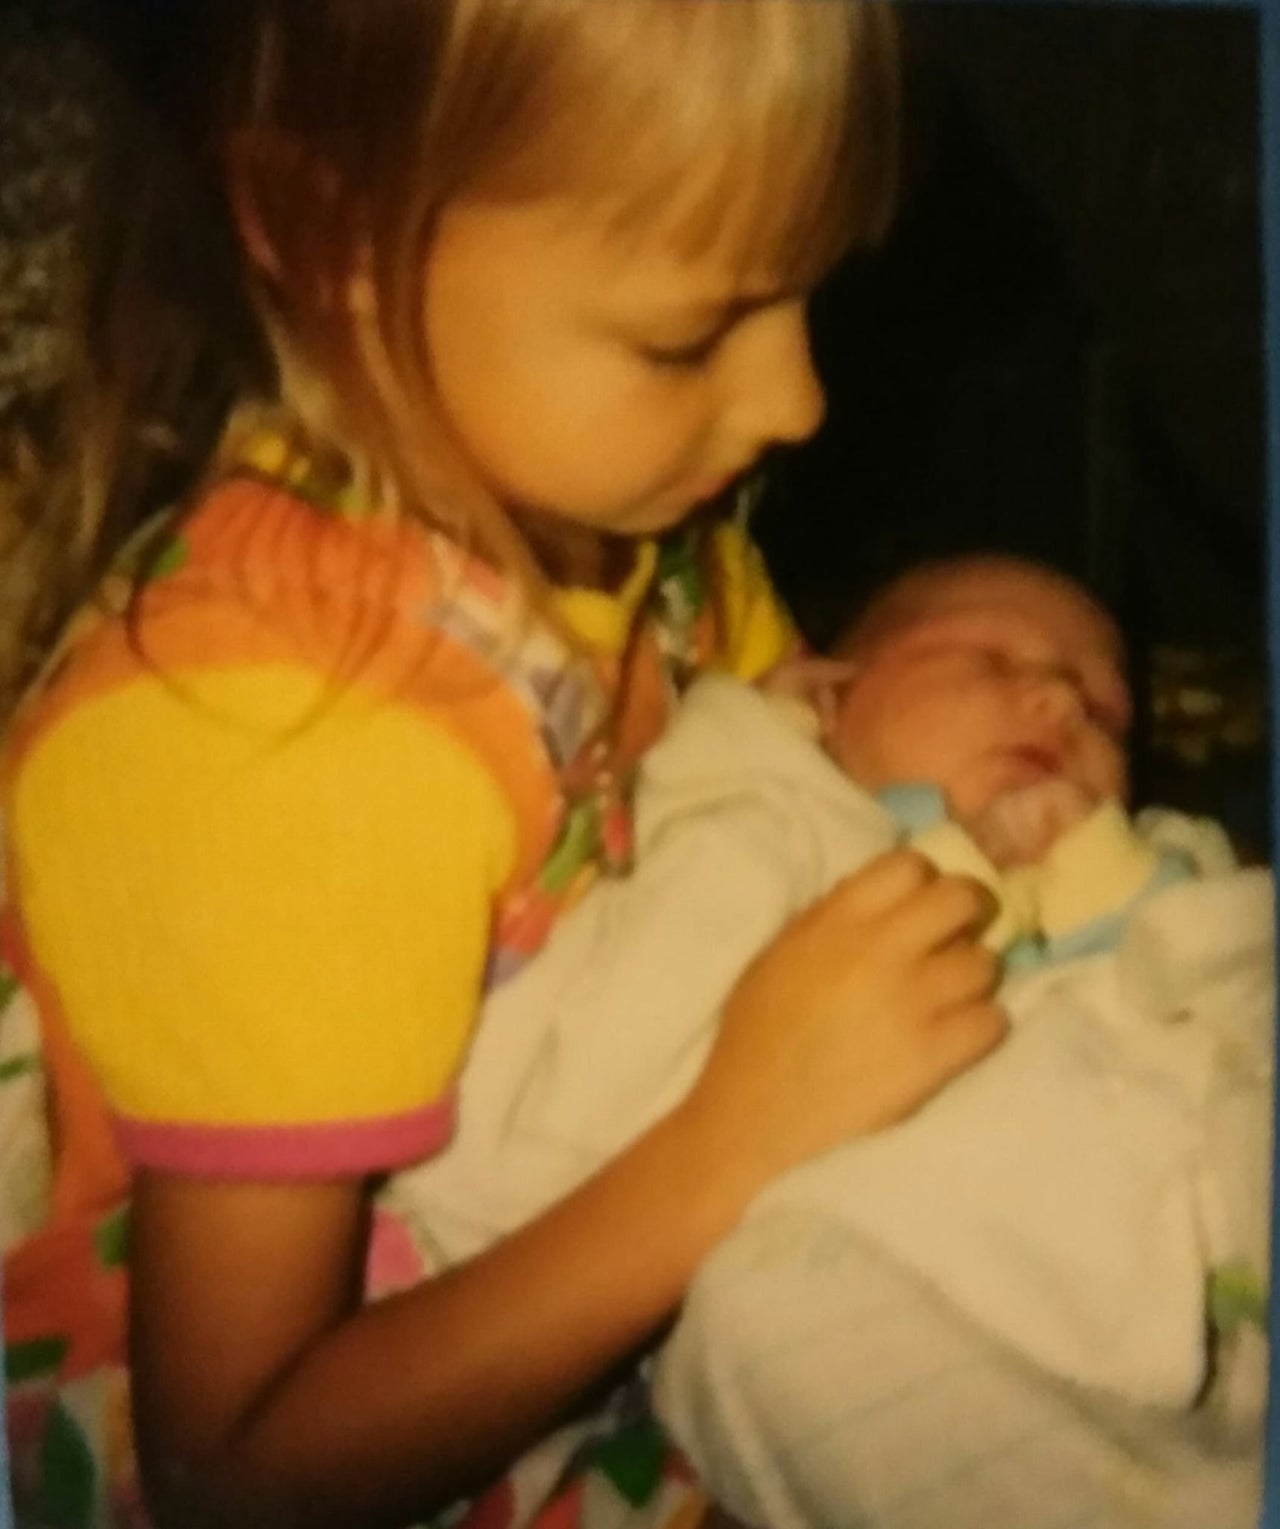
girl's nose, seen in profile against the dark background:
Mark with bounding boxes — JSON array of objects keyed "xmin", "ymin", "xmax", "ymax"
[{"xmin": 725, "ymin": 298, "xmax": 826, "ymax": 450}]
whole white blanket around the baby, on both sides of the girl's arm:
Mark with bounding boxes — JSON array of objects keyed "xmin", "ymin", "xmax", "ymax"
[{"xmin": 383, "ymin": 679, "xmax": 1274, "ymax": 1529}]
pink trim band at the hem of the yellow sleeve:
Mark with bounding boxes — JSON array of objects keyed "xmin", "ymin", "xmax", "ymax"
[{"xmin": 115, "ymin": 1093, "xmax": 456, "ymax": 1179}]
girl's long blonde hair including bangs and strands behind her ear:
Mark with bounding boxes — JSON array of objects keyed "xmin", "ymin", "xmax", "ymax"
[{"xmin": 4, "ymin": 0, "xmax": 898, "ymax": 709}]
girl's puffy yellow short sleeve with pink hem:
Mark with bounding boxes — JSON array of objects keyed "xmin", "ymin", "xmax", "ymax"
[{"xmin": 9, "ymin": 664, "xmax": 517, "ymax": 1176}]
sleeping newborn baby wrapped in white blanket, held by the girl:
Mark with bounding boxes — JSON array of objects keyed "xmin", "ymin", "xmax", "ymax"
[{"xmin": 386, "ymin": 558, "xmax": 1274, "ymax": 1529}]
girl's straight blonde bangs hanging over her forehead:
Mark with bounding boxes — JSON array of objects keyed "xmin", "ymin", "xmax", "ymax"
[{"xmin": 458, "ymin": 0, "xmax": 899, "ymax": 287}]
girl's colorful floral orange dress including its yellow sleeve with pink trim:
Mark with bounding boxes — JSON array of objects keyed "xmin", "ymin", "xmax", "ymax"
[{"xmin": 0, "ymin": 458, "xmax": 794, "ymax": 1529}]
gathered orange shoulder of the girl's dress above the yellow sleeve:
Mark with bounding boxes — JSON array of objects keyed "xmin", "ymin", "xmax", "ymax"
[{"xmin": 15, "ymin": 474, "xmax": 559, "ymax": 739}]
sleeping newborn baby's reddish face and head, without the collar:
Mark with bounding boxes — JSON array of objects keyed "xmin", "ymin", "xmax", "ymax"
[{"xmin": 827, "ymin": 564, "xmax": 1130, "ymax": 864}]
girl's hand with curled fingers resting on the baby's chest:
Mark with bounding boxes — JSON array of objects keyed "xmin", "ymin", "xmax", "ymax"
[{"xmin": 687, "ymin": 850, "xmax": 1006, "ymax": 1182}]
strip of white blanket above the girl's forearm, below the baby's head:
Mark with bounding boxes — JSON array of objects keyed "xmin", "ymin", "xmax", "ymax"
[{"xmin": 379, "ymin": 677, "xmax": 899, "ymax": 1264}]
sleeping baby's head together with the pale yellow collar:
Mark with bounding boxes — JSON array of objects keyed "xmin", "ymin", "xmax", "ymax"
[{"xmin": 768, "ymin": 558, "xmax": 1168, "ymax": 963}]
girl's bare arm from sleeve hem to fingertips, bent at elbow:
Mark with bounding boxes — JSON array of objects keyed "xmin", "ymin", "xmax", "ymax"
[{"xmin": 132, "ymin": 853, "xmax": 1003, "ymax": 1529}]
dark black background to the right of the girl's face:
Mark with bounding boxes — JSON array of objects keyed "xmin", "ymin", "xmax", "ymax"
[{"xmin": 757, "ymin": 3, "xmax": 1268, "ymax": 846}]
